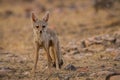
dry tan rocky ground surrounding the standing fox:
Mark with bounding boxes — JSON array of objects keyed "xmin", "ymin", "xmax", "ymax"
[{"xmin": 0, "ymin": 0, "xmax": 120, "ymax": 80}]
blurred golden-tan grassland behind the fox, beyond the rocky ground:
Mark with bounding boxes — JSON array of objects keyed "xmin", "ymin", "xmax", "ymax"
[{"xmin": 0, "ymin": 0, "xmax": 120, "ymax": 51}]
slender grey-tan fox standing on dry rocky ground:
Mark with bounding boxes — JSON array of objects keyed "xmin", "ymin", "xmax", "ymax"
[{"xmin": 32, "ymin": 11, "xmax": 63, "ymax": 73}]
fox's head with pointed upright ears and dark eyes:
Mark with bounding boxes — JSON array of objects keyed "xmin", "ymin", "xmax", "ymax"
[{"xmin": 32, "ymin": 12, "xmax": 49, "ymax": 34}]
